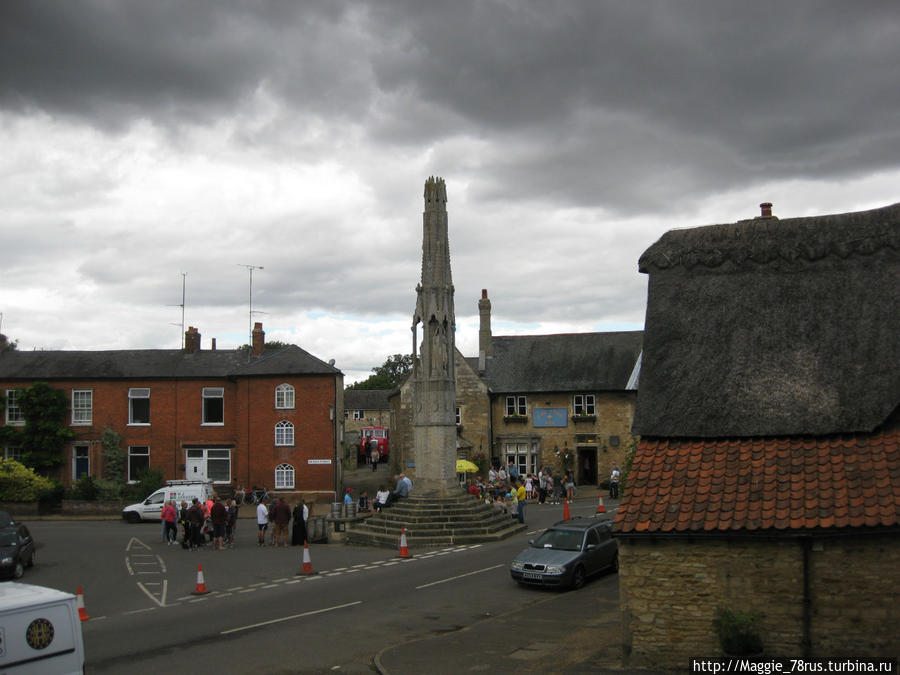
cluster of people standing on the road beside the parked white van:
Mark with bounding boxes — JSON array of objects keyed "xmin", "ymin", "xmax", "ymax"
[{"xmin": 160, "ymin": 494, "xmax": 238, "ymax": 551}]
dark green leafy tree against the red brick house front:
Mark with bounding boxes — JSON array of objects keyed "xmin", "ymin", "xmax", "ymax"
[{"xmin": 18, "ymin": 382, "xmax": 75, "ymax": 474}]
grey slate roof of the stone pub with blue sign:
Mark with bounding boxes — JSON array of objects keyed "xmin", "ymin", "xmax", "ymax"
[{"xmin": 478, "ymin": 331, "xmax": 643, "ymax": 394}]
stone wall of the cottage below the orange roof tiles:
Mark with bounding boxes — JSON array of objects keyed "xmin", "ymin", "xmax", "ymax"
[{"xmin": 619, "ymin": 536, "xmax": 900, "ymax": 669}]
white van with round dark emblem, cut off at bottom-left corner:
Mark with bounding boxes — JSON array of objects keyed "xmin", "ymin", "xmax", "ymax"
[{"xmin": 0, "ymin": 582, "xmax": 84, "ymax": 675}]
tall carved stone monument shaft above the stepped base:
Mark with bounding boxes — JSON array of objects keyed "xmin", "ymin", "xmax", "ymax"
[{"xmin": 412, "ymin": 177, "xmax": 460, "ymax": 497}]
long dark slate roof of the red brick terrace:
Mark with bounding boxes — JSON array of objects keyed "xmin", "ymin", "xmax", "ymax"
[{"xmin": 0, "ymin": 345, "xmax": 341, "ymax": 381}]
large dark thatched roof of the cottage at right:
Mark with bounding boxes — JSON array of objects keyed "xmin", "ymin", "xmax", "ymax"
[{"xmin": 634, "ymin": 204, "xmax": 900, "ymax": 438}]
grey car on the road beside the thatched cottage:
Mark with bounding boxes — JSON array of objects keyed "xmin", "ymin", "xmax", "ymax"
[{"xmin": 509, "ymin": 518, "xmax": 619, "ymax": 588}]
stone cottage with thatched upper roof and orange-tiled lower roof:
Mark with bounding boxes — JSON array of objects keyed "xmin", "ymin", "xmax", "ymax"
[{"xmin": 614, "ymin": 204, "xmax": 900, "ymax": 668}]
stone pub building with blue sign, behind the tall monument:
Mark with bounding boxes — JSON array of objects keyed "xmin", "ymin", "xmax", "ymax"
[{"xmin": 391, "ymin": 291, "xmax": 642, "ymax": 485}]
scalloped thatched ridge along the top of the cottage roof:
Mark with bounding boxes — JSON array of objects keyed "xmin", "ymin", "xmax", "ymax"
[{"xmin": 638, "ymin": 203, "xmax": 900, "ymax": 272}]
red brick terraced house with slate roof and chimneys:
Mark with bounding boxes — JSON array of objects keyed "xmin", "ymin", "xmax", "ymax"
[{"xmin": 0, "ymin": 323, "xmax": 343, "ymax": 502}]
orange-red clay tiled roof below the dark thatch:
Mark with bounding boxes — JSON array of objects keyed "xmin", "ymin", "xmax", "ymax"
[{"xmin": 614, "ymin": 429, "xmax": 900, "ymax": 534}]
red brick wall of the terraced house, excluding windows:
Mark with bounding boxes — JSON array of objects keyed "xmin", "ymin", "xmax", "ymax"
[{"xmin": 0, "ymin": 376, "xmax": 340, "ymax": 492}]
